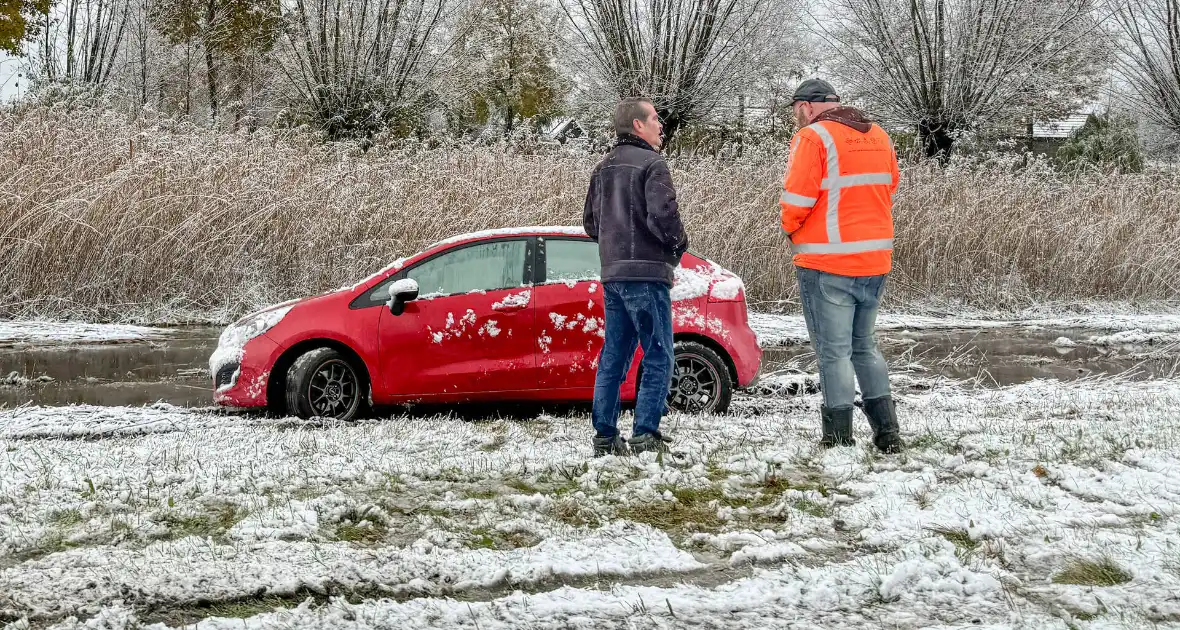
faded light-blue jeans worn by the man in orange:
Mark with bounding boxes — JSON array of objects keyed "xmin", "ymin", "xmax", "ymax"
[{"xmin": 795, "ymin": 267, "xmax": 890, "ymax": 409}]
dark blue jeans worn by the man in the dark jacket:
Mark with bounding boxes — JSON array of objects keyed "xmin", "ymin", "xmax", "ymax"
[{"xmin": 594, "ymin": 282, "xmax": 674, "ymax": 438}]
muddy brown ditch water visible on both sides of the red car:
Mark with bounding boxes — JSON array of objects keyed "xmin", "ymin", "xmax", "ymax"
[{"xmin": 0, "ymin": 328, "xmax": 1180, "ymax": 408}]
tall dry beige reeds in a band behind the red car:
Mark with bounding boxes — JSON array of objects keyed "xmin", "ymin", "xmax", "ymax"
[{"xmin": 0, "ymin": 109, "xmax": 1180, "ymax": 322}]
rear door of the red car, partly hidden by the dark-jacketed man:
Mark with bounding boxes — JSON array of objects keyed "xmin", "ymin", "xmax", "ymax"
[{"xmin": 535, "ymin": 237, "xmax": 607, "ymax": 389}]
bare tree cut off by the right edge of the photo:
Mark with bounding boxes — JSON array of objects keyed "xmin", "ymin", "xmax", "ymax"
[{"xmin": 1114, "ymin": 0, "xmax": 1180, "ymax": 133}]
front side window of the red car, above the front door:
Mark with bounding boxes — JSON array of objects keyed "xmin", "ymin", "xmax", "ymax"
[{"xmin": 406, "ymin": 239, "xmax": 529, "ymax": 296}]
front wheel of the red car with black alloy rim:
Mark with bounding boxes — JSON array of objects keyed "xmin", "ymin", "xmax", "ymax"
[{"xmin": 287, "ymin": 348, "xmax": 368, "ymax": 420}]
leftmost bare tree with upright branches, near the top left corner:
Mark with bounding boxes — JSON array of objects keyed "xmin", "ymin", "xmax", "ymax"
[{"xmin": 28, "ymin": 0, "xmax": 131, "ymax": 86}]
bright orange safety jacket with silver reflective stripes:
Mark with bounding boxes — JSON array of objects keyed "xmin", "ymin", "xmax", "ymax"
[{"xmin": 779, "ymin": 120, "xmax": 899, "ymax": 276}]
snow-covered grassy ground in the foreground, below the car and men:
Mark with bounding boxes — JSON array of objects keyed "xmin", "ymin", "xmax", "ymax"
[{"xmin": 0, "ymin": 380, "xmax": 1180, "ymax": 630}]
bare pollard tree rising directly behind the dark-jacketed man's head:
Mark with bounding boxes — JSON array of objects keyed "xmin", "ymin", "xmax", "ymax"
[{"xmin": 563, "ymin": 0, "xmax": 786, "ymax": 145}]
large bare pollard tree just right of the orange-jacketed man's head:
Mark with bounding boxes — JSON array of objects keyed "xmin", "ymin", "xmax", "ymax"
[{"xmin": 817, "ymin": 0, "xmax": 1104, "ymax": 157}]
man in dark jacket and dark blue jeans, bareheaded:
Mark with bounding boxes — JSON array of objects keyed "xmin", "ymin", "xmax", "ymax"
[{"xmin": 583, "ymin": 98, "xmax": 688, "ymax": 457}]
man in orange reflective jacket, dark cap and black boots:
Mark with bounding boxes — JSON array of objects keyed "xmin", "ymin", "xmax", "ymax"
[{"xmin": 779, "ymin": 79, "xmax": 902, "ymax": 453}]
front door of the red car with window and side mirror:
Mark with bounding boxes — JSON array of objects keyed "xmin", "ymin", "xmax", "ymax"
[{"xmin": 375, "ymin": 238, "xmax": 537, "ymax": 400}]
